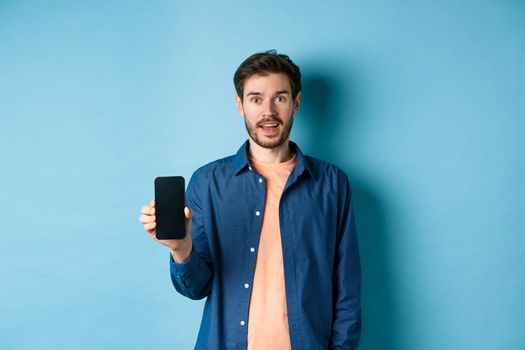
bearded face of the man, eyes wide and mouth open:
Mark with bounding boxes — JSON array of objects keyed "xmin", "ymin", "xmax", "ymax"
[{"xmin": 235, "ymin": 73, "xmax": 301, "ymax": 148}]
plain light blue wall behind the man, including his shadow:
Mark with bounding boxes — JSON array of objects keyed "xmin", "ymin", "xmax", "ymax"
[{"xmin": 0, "ymin": 0, "xmax": 525, "ymax": 350}]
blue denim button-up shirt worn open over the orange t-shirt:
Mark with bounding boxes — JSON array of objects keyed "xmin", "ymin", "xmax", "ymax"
[{"xmin": 170, "ymin": 141, "xmax": 361, "ymax": 350}]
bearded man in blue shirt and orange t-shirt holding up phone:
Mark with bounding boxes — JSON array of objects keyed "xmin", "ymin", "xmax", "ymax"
[{"xmin": 140, "ymin": 51, "xmax": 361, "ymax": 350}]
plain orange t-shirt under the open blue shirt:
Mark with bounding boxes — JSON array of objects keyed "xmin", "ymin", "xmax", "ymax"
[{"xmin": 248, "ymin": 154, "xmax": 297, "ymax": 350}]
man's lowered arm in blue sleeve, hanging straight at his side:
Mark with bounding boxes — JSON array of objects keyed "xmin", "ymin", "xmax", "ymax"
[{"xmin": 330, "ymin": 173, "xmax": 361, "ymax": 350}]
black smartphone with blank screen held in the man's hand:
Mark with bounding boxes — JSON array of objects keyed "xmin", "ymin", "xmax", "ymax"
[{"xmin": 155, "ymin": 176, "xmax": 186, "ymax": 239}]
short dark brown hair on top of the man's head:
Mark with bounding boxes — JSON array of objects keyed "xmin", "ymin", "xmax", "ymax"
[{"xmin": 233, "ymin": 50, "xmax": 301, "ymax": 101}]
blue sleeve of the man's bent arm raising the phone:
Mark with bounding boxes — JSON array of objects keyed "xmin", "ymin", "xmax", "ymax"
[{"xmin": 170, "ymin": 174, "xmax": 213, "ymax": 300}]
